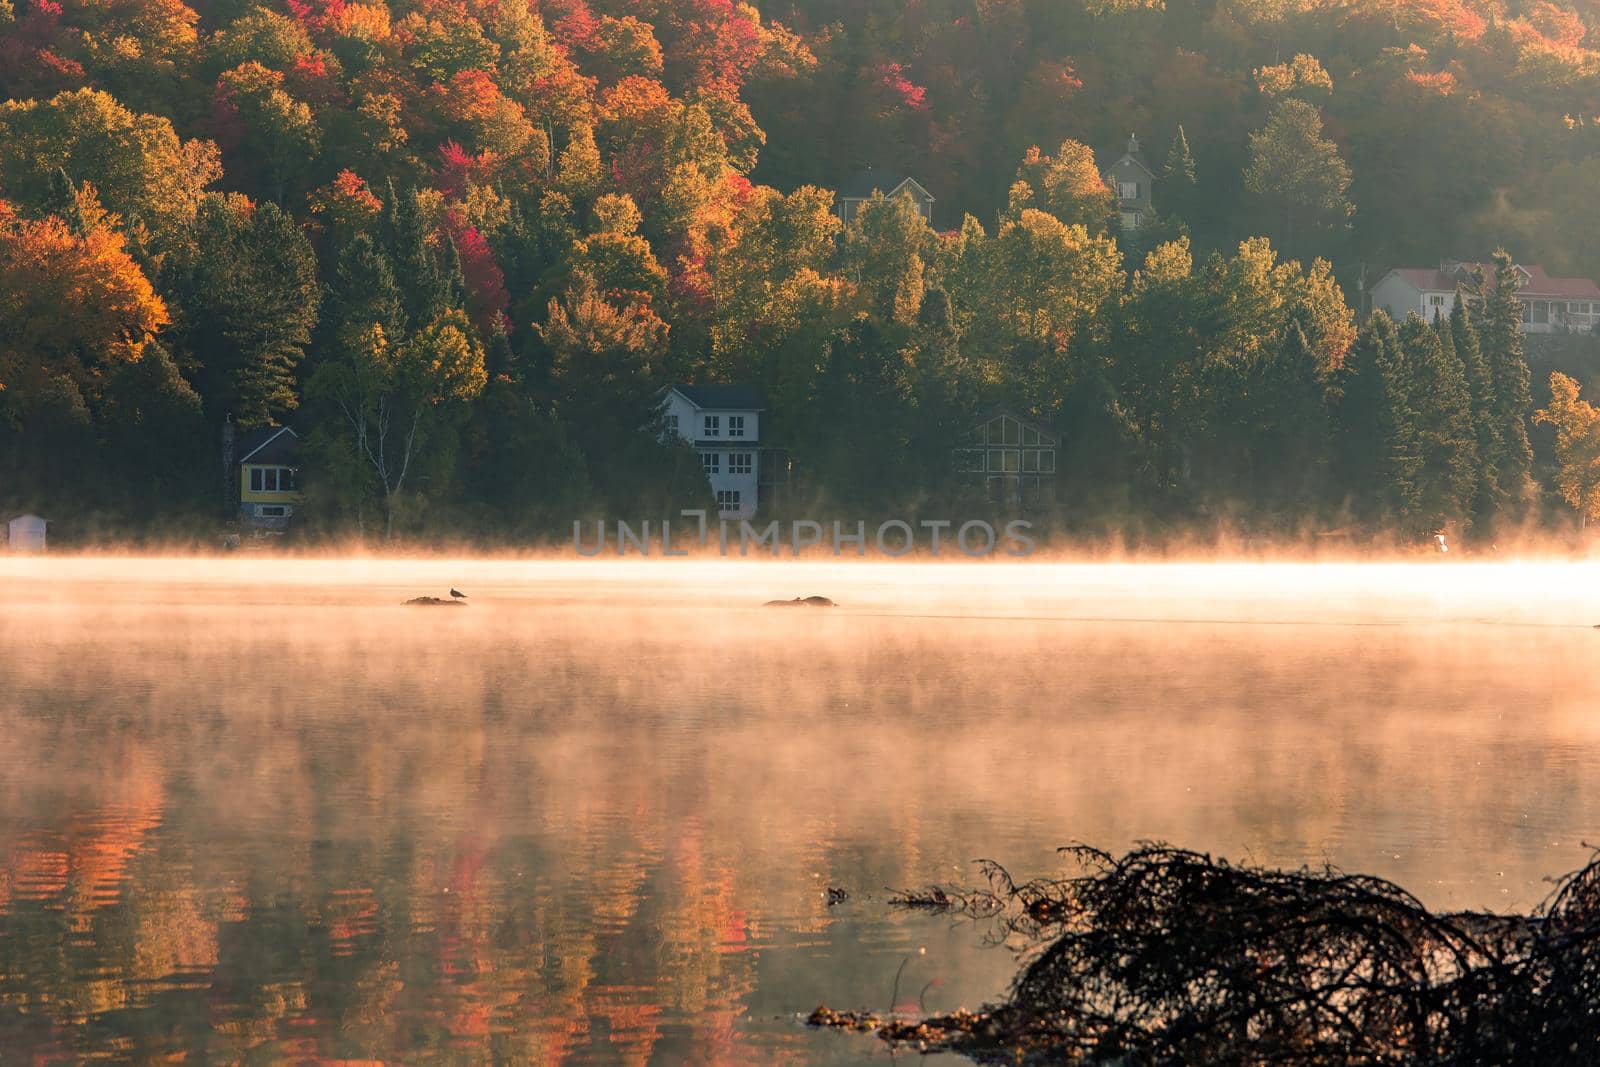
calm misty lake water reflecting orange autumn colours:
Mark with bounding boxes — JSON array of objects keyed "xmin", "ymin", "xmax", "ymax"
[{"xmin": 0, "ymin": 557, "xmax": 1600, "ymax": 1064}]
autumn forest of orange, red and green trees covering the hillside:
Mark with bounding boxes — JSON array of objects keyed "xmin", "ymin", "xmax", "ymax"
[{"xmin": 0, "ymin": 0, "xmax": 1600, "ymax": 542}]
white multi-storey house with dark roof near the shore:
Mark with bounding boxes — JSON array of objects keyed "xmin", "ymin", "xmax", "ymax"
[{"xmin": 662, "ymin": 386, "xmax": 770, "ymax": 518}]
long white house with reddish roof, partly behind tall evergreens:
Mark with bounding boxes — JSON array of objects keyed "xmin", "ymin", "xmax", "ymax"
[{"xmin": 1373, "ymin": 259, "xmax": 1600, "ymax": 333}]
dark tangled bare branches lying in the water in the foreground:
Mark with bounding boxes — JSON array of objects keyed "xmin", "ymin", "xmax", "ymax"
[{"xmin": 811, "ymin": 845, "xmax": 1600, "ymax": 1064}]
